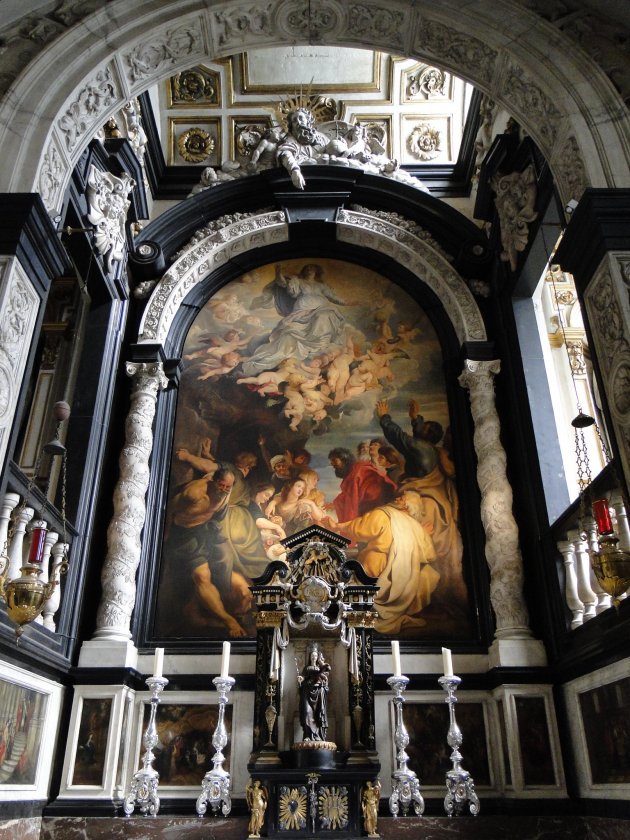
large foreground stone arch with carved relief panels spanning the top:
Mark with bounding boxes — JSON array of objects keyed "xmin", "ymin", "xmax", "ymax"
[{"xmin": 0, "ymin": 0, "xmax": 630, "ymax": 213}]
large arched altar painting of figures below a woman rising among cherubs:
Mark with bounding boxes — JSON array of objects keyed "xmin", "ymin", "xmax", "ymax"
[{"xmin": 155, "ymin": 259, "xmax": 469, "ymax": 639}]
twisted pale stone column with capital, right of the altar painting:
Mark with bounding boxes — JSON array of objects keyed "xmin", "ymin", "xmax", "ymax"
[{"xmin": 459, "ymin": 360, "xmax": 532, "ymax": 639}]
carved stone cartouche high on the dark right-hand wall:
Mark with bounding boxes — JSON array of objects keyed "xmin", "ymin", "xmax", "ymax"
[{"xmin": 491, "ymin": 164, "xmax": 538, "ymax": 271}]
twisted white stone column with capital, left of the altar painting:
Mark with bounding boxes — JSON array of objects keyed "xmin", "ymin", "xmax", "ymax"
[{"xmin": 94, "ymin": 362, "xmax": 168, "ymax": 641}]
